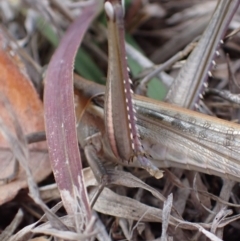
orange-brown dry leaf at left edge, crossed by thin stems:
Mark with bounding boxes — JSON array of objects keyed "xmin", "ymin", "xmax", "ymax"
[{"xmin": 0, "ymin": 31, "xmax": 51, "ymax": 205}]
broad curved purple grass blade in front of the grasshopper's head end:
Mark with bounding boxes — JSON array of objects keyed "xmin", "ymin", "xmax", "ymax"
[{"xmin": 44, "ymin": 0, "xmax": 99, "ymax": 218}]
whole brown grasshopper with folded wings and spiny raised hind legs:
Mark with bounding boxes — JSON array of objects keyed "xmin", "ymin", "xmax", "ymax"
[{"xmin": 75, "ymin": 0, "xmax": 240, "ymax": 198}]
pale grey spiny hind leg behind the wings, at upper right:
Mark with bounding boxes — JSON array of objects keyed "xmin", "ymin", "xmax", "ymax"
[{"xmin": 165, "ymin": 0, "xmax": 239, "ymax": 109}]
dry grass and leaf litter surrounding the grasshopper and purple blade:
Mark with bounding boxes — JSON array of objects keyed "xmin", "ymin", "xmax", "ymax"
[{"xmin": 0, "ymin": 0, "xmax": 240, "ymax": 241}]
